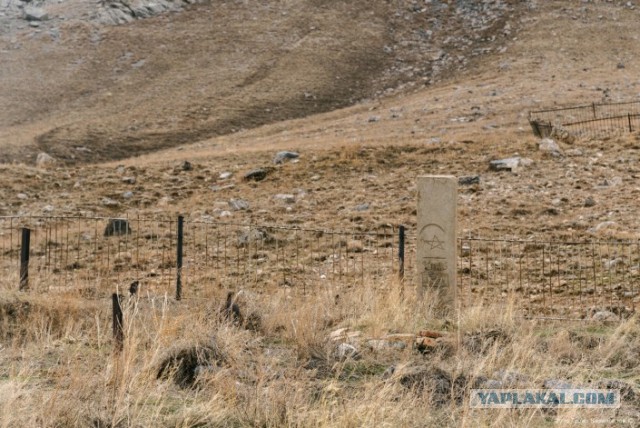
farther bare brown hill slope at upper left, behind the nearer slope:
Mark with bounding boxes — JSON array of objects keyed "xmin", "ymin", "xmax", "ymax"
[{"xmin": 0, "ymin": 0, "xmax": 529, "ymax": 162}]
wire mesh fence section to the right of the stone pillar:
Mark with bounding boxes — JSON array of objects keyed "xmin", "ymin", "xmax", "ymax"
[{"xmin": 458, "ymin": 239, "xmax": 640, "ymax": 319}]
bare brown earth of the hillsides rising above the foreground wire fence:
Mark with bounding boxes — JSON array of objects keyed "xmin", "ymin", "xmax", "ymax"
[{"xmin": 0, "ymin": 2, "xmax": 640, "ymax": 239}]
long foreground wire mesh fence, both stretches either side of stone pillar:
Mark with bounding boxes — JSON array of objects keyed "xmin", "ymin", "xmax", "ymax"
[{"xmin": 0, "ymin": 217, "xmax": 640, "ymax": 319}]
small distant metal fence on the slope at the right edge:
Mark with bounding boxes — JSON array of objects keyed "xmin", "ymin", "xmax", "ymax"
[{"xmin": 529, "ymin": 101, "xmax": 640, "ymax": 137}]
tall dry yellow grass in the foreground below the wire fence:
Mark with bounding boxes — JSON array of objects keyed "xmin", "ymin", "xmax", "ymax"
[{"xmin": 0, "ymin": 284, "xmax": 640, "ymax": 427}]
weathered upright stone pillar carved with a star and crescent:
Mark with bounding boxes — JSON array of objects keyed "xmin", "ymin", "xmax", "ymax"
[{"xmin": 416, "ymin": 175, "xmax": 458, "ymax": 315}]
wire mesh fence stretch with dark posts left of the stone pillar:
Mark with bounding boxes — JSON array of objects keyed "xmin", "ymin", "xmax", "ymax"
[{"xmin": 0, "ymin": 217, "xmax": 411, "ymax": 298}]
